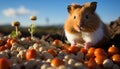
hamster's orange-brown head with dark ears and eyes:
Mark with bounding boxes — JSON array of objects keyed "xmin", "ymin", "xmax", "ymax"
[{"xmin": 67, "ymin": 2, "xmax": 100, "ymax": 32}]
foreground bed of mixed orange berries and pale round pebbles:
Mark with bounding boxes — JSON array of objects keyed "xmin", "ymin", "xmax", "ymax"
[{"xmin": 0, "ymin": 37, "xmax": 120, "ymax": 69}]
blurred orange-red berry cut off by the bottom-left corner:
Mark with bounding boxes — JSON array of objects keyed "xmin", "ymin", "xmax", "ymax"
[{"xmin": 0, "ymin": 58, "xmax": 10, "ymax": 69}]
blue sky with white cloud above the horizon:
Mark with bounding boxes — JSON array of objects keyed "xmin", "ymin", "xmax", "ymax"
[{"xmin": 0, "ymin": 0, "xmax": 120, "ymax": 26}]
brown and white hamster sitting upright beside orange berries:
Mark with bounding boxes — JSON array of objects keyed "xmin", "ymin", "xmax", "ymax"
[{"xmin": 64, "ymin": 2, "xmax": 110, "ymax": 49}]
